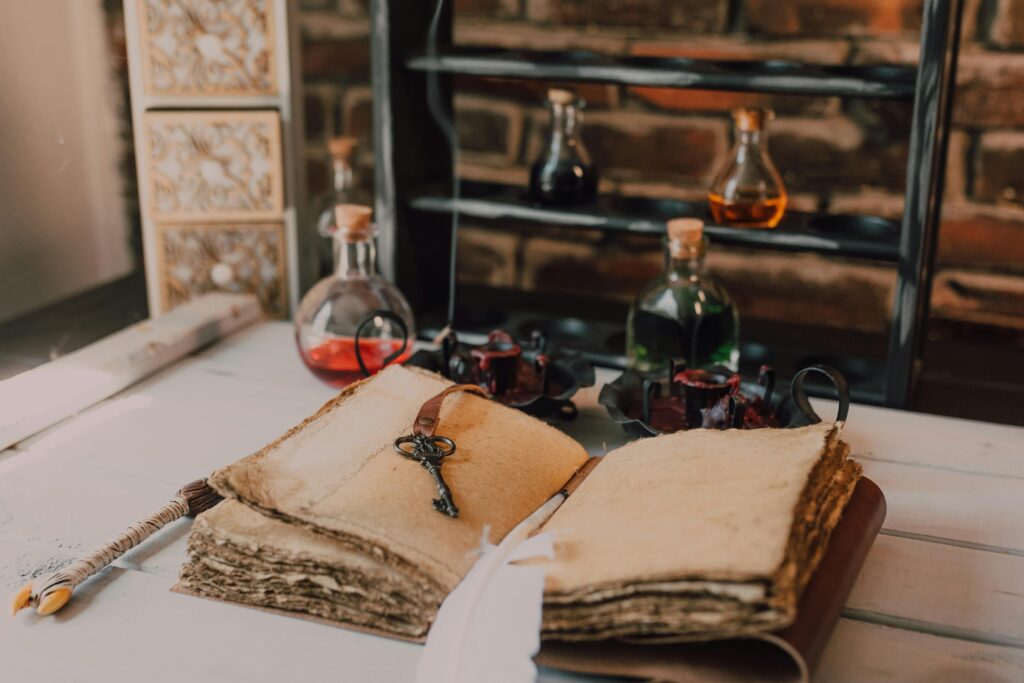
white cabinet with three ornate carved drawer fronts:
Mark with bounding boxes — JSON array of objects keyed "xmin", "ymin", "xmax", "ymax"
[{"xmin": 125, "ymin": 0, "xmax": 302, "ymax": 316}]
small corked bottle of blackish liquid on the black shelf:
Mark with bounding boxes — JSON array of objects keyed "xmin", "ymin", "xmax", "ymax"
[{"xmin": 529, "ymin": 88, "xmax": 597, "ymax": 207}]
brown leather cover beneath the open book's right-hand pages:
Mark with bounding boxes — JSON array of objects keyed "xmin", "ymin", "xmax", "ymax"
[{"xmin": 537, "ymin": 477, "xmax": 886, "ymax": 683}]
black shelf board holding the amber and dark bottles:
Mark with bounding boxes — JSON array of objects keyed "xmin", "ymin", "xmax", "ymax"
[{"xmin": 410, "ymin": 182, "xmax": 899, "ymax": 262}]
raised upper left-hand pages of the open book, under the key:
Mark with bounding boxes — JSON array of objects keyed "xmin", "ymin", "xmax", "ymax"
[{"xmin": 211, "ymin": 367, "xmax": 587, "ymax": 595}]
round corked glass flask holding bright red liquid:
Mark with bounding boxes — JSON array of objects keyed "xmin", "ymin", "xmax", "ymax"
[{"xmin": 295, "ymin": 204, "xmax": 416, "ymax": 387}]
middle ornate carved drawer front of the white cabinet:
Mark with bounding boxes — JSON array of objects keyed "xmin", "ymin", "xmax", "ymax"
[{"xmin": 144, "ymin": 112, "xmax": 284, "ymax": 221}]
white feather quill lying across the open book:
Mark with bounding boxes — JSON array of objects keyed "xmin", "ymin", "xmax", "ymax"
[{"xmin": 416, "ymin": 494, "xmax": 565, "ymax": 683}]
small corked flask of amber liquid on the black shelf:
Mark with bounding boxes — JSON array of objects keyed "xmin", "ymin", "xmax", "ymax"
[{"xmin": 708, "ymin": 109, "xmax": 786, "ymax": 227}]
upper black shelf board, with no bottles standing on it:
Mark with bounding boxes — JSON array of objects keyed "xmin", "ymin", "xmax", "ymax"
[{"xmin": 406, "ymin": 47, "xmax": 916, "ymax": 99}]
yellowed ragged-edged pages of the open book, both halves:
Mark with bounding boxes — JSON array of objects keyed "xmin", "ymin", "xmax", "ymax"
[{"xmin": 179, "ymin": 367, "xmax": 860, "ymax": 655}]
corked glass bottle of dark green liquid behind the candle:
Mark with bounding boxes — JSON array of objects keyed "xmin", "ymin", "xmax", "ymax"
[{"xmin": 626, "ymin": 218, "xmax": 739, "ymax": 373}]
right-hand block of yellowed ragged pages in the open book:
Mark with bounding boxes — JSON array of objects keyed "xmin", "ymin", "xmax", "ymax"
[{"xmin": 544, "ymin": 424, "xmax": 860, "ymax": 639}]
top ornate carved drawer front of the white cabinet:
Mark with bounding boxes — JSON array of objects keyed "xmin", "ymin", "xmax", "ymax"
[{"xmin": 136, "ymin": 0, "xmax": 278, "ymax": 95}]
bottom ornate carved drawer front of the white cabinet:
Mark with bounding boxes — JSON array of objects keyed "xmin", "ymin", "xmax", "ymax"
[{"xmin": 157, "ymin": 222, "xmax": 288, "ymax": 316}]
